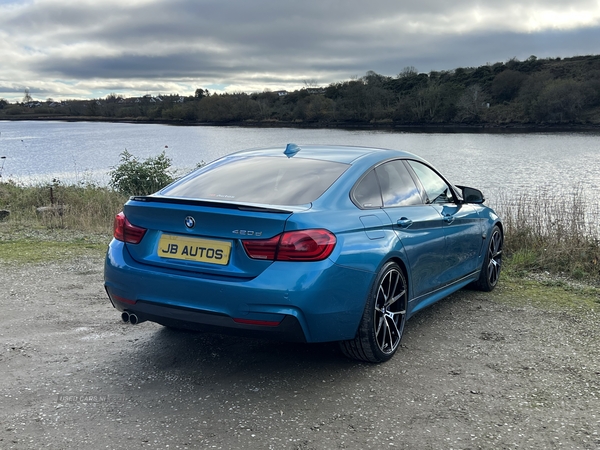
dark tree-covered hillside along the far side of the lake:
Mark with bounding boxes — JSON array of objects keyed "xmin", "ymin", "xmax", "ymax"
[{"xmin": 0, "ymin": 56, "xmax": 600, "ymax": 126}]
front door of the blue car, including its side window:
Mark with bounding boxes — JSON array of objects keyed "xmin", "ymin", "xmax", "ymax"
[{"xmin": 408, "ymin": 161, "xmax": 484, "ymax": 284}]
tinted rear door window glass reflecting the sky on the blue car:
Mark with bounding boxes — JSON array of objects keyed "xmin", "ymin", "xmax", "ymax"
[{"xmin": 375, "ymin": 160, "xmax": 423, "ymax": 208}]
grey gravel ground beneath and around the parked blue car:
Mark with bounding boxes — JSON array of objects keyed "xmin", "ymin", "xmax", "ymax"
[{"xmin": 0, "ymin": 258, "xmax": 600, "ymax": 449}]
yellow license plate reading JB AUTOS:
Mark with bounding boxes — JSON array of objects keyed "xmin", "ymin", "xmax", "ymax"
[{"xmin": 157, "ymin": 234, "xmax": 231, "ymax": 266}]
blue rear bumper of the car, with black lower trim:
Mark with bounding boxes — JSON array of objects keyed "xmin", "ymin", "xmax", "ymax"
[{"xmin": 105, "ymin": 240, "xmax": 374, "ymax": 342}]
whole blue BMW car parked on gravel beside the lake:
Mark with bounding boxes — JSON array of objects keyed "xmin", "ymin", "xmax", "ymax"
[{"xmin": 105, "ymin": 144, "xmax": 503, "ymax": 363}]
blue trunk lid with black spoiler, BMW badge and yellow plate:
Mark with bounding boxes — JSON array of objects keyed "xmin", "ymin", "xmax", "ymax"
[{"xmin": 124, "ymin": 196, "xmax": 300, "ymax": 279}]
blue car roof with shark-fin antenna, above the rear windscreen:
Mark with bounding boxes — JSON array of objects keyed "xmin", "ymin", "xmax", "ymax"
[{"xmin": 230, "ymin": 144, "xmax": 421, "ymax": 164}]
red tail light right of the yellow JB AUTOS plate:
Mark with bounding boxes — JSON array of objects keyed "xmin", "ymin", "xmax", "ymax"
[{"xmin": 242, "ymin": 229, "xmax": 336, "ymax": 261}]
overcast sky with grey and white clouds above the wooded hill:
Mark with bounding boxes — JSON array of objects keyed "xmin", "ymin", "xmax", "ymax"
[{"xmin": 0, "ymin": 0, "xmax": 600, "ymax": 102}]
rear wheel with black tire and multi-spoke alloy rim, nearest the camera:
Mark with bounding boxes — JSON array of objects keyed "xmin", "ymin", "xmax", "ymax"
[{"xmin": 340, "ymin": 262, "xmax": 408, "ymax": 363}]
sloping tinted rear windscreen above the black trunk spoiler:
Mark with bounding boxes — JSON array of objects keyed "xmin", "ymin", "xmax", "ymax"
[{"xmin": 161, "ymin": 156, "xmax": 349, "ymax": 205}]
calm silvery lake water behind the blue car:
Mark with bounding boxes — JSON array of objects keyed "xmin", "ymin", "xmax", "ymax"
[{"xmin": 0, "ymin": 121, "xmax": 600, "ymax": 205}]
